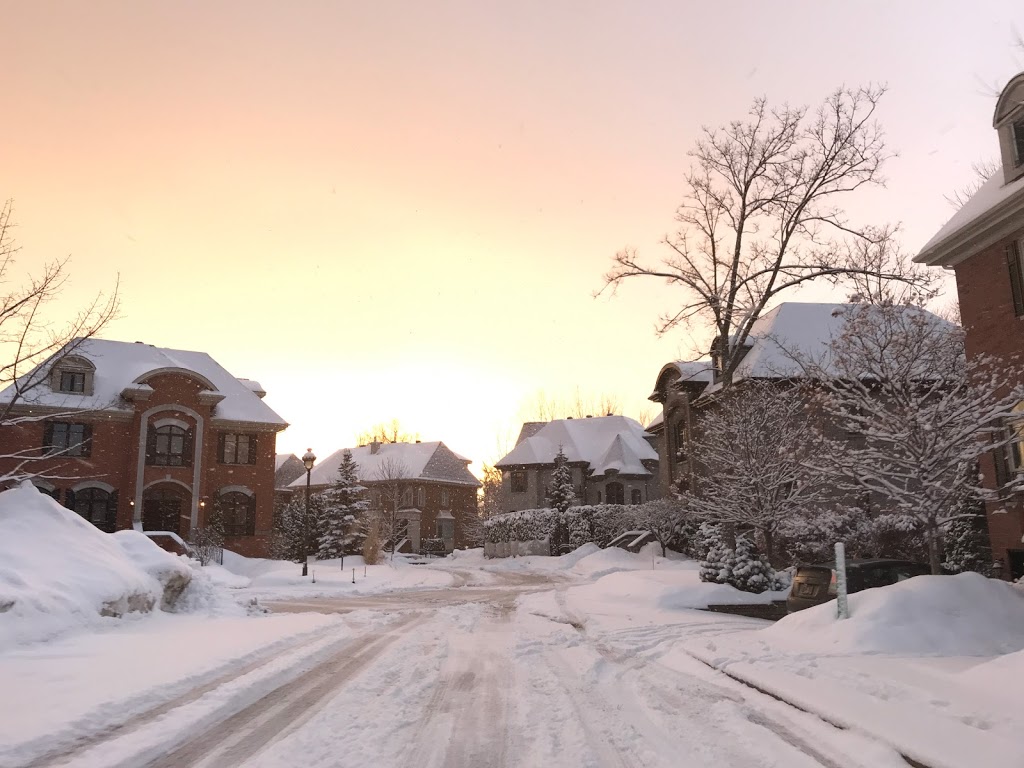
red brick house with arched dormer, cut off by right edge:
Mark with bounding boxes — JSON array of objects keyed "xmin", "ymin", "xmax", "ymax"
[{"xmin": 914, "ymin": 73, "xmax": 1024, "ymax": 579}]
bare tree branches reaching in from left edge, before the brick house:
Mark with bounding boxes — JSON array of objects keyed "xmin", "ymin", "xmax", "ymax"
[{"xmin": 0, "ymin": 200, "xmax": 118, "ymax": 480}]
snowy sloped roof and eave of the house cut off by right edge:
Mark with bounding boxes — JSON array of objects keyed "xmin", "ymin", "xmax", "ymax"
[{"xmin": 913, "ymin": 168, "xmax": 1024, "ymax": 265}]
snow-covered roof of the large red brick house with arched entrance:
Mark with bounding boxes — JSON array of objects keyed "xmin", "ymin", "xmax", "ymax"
[{"xmin": 0, "ymin": 339, "xmax": 288, "ymax": 429}]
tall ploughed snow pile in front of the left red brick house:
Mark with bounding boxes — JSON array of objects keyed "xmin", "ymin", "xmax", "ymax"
[{"xmin": 0, "ymin": 483, "xmax": 163, "ymax": 648}]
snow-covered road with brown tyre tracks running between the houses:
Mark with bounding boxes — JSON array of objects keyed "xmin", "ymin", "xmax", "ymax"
[{"xmin": 32, "ymin": 569, "xmax": 907, "ymax": 768}]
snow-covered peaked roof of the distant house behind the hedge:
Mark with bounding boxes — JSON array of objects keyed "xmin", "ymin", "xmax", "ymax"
[{"xmin": 495, "ymin": 416, "xmax": 657, "ymax": 475}]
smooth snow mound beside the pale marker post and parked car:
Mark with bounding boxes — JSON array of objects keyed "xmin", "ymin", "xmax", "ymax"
[{"xmin": 764, "ymin": 573, "xmax": 1024, "ymax": 656}]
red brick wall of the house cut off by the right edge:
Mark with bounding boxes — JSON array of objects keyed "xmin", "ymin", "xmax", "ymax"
[{"xmin": 954, "ymin": 229, "xmax": 1024, "ymax": 574}]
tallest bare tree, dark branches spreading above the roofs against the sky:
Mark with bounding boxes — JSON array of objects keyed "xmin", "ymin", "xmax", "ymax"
[{"xmin": 602, "ymin": 86, "xmax": 935, "ymax": 387}]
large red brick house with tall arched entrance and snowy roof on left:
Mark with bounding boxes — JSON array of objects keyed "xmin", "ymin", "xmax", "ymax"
[{"xmin": 0, "ymin": 339, "xmax": 288, "ymax": 556}]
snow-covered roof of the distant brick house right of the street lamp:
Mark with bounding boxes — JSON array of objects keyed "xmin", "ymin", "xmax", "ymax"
[{"xmin": 291, "ymin": 440, "xmax": 480, "ymax": 487}]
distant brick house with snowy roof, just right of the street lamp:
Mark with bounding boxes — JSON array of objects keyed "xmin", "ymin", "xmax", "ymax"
[{"xmin": 288, "ymin": 440, "xmax": 480, "ymax": 552}]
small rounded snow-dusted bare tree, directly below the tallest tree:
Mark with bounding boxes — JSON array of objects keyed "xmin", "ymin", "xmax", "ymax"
[{"xmin": 687, "ymin": 380, "xmax": 828, "ymax": 560}]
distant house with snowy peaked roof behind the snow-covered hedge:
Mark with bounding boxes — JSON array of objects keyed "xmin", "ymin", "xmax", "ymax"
[{"xmin": 495, "ymin": 416, "xmax": 660, "ymax": 511}]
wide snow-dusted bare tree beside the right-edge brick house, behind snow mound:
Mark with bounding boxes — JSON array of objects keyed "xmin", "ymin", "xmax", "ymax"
[{"xmin": 805, "ymin": 306, "xmax": 1024, "ymax": 573}]
